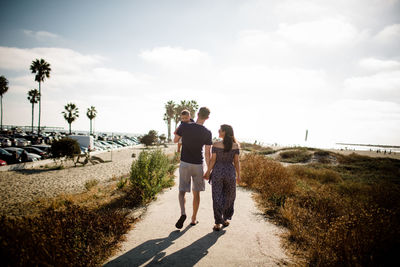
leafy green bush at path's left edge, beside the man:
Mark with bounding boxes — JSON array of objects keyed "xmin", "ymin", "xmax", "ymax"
[{"xmin": 130, "ymin": 149, "xmax": 173, "ymax": 201}]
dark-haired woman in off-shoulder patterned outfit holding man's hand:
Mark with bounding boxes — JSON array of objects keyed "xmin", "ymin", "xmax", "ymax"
[{"xmin": 204, "ymin": 124, "xmax": 240, "ymax": 231}]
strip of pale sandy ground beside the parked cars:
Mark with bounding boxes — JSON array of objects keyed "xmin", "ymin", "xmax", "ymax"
[{"xmin": 0, "ymin": 145, "xmax": 176, "ymax": 217}]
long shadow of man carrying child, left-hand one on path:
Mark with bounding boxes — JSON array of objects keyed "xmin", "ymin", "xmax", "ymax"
[{"xmin": 104, "ymin": 225, "xmax": 191, "ymax": 267}]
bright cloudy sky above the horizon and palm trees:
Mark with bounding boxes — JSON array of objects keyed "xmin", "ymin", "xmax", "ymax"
[{"xmin": 0, "ymin": 0, "xmax": 400, "ymax": 147}]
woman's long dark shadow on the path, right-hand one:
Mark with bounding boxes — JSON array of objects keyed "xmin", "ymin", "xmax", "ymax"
[{"xmin": 146, "ymin": 230, "xmax": 225, "ymax": 267}]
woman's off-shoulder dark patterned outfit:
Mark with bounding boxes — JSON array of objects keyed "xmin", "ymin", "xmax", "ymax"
[{"xmin": 210, "ymin": 146, "xmax": 239, "ymax": 224}]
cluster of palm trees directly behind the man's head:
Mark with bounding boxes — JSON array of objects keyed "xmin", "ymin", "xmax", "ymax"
[{"xmin": 164, "ymin": 100, "xmax": 199, "ymax": 142}]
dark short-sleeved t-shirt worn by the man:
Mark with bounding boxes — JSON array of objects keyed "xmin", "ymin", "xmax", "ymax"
[{"xmin": 176, "ymin": 122, "xmax": 212, "ymax": 164}]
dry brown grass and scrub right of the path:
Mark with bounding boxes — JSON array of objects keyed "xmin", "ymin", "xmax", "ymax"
[{"xmin": 242, "ymin": 152, "xmax": 400, "ymax": 266}]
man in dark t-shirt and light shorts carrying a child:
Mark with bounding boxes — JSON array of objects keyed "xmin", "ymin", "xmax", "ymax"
[{"xmin": 174, "ymin": 107, "xmax": 212, "ymax": 229}]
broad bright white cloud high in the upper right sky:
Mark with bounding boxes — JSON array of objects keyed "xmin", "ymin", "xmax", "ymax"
[{"xmin": 277, "ymin": 18, "xmax": 361, "ymax": 46}]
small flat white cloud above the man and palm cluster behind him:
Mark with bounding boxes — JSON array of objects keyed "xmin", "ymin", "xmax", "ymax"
[{"xmin": 139, "ymin": 46, "xmax": 210, "ymax": 70}]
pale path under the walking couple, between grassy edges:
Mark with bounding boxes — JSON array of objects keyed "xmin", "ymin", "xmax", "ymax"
[{"xmin": 105, "ymin": 173, "xmax": 290, "ymax": 267}]
